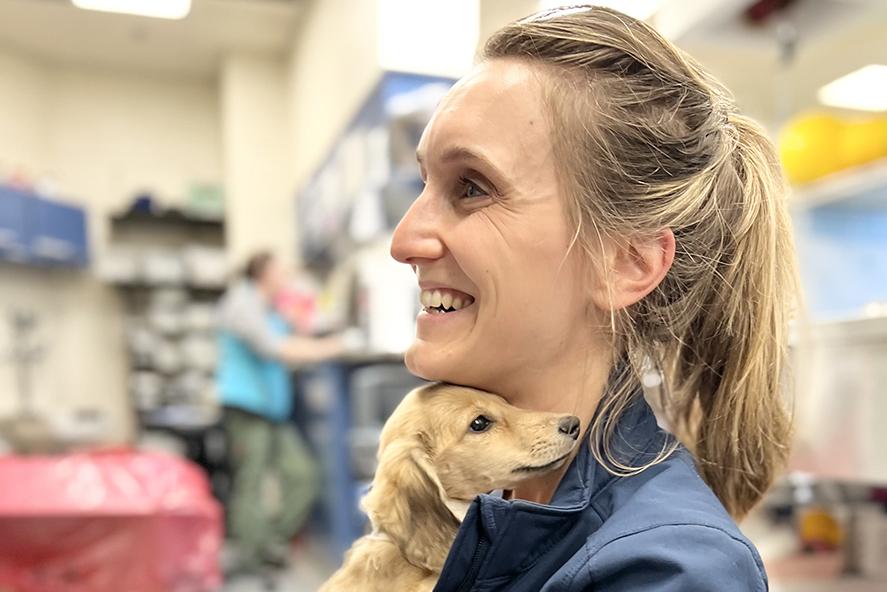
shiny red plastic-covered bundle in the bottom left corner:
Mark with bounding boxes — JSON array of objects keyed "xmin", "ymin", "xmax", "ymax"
[{"xmin": 0, "ymin": 451, "xmax": 223, "ymax": 592}]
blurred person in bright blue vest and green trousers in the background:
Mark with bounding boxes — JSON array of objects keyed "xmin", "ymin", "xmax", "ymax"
[{"xmin": 217, "ymin": 252, "xmax": 343, "ymax": 573}]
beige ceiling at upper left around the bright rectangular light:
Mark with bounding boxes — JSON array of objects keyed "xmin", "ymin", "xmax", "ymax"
[{"xmin": 0, "ymin": 0, "xmax": 306, "ymax": 78}]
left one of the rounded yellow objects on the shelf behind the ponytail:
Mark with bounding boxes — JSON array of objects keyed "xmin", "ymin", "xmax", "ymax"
[{"xmin": 779, "ymin": 113, "xmax": 844, "ymax": 185}]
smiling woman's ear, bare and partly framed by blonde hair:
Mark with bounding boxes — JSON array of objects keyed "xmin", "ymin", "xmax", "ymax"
[{"xmin": 591, "ymin": 228, "xmax": 675, "ymax": 310}]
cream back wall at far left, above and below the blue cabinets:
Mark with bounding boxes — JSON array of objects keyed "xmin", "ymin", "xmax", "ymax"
[{"xmin": 0, "ymin": 48, "xmax": 222, "ymax": 441}]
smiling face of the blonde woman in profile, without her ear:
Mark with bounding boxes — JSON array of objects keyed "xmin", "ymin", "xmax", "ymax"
[{"xmin": 391, "ymin": 60, "xmax": 590, "ymax": 400}]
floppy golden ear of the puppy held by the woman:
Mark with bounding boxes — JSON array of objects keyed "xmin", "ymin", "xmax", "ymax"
[{"xmin": 363, "ymin": 438, "xmax": 459, "ymax": 572}]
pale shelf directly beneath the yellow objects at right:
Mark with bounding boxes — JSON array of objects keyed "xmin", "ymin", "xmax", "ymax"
[{"xmin": 791, "ymin": 159, "xmax": 887, "ymax": 210}]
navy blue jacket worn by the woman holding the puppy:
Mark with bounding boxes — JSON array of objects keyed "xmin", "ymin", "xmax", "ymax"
[{"xmin": 435, "ymin": 398, "xmax": 767, "ymax": 592}]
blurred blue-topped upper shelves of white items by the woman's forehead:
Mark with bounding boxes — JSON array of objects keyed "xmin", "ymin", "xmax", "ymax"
[{"xmin": 297, "ymin": 72, "xmax": 455, "ymax": 270}]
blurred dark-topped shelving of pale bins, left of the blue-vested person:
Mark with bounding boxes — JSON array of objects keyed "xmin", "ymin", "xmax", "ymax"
[{"xmin": 98, "ymin": 209, "xmax": 230, "ymax": 501}]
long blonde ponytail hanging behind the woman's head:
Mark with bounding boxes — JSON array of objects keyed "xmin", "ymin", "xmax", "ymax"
[{"xmin": 665, "ymin": 115, "xmax": 796, "ymax": 517}]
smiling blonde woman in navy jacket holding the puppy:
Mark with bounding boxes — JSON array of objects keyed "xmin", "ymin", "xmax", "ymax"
[{"xmin": 392, "ymin": 7, "xmax": 794, "ymax": 592}]
